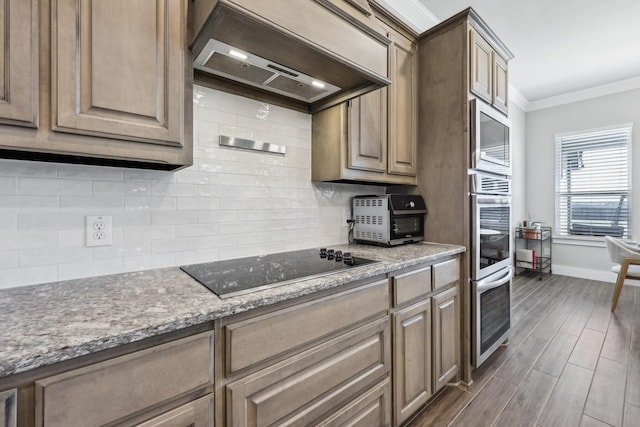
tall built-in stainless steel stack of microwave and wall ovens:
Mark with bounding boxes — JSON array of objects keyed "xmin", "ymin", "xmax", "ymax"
[{"xmin": 469, "ymin": 100, "xmax": 513, "ymax": 367}]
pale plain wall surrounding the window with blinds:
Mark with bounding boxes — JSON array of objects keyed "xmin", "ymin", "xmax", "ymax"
[{"xmin": 526, "ymin": 89, "xmax": 640, "ymax": 281}]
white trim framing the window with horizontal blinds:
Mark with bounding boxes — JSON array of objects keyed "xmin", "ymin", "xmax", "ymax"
[{"xmin": 553, "ymin": 122, "xmax": 633, "ymax": 247}]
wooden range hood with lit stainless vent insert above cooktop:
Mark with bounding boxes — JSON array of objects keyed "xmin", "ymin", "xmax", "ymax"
[{"xmin": 191, "ymin": 0, "xmax": 390, "ymax": 112}]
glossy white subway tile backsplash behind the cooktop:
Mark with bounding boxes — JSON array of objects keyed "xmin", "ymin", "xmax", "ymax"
[{"xmin": 0, "ymin": 86, "xmax": 384, "ymax": 288}]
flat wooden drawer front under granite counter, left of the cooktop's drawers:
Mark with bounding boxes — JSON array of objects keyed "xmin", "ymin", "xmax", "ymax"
[{"xmin": 36, "ymin": 333, "xmax": 213, "ymax": 427}]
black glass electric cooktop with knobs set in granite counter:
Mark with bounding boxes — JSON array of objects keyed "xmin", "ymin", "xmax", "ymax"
[{"xmin": 180, "ymin": 248, "xmax": 377, "ymax": 298}]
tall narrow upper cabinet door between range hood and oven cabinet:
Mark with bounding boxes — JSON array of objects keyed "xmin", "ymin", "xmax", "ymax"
[{"xmin": 388, "ymin": 28, "xmax": 418, "ymax": 176}]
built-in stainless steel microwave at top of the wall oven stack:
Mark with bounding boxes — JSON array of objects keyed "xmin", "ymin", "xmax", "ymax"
[{"xmin": 470, "ymin": 99, "xmax": 511, "ymax": 176}]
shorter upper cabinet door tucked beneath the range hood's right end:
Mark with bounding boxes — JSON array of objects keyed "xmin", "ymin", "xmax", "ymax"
[{"xmin": 347, "ymin": 88, "xmax": 388, "ymax": 172}]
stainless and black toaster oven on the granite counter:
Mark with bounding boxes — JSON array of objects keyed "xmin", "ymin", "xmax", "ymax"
[{"xmin": 353, "ymin": 194, "xmax": 427, "ymax": 246}]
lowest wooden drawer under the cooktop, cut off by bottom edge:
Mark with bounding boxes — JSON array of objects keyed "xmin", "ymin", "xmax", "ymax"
[{"xmin": 318, "ymin": 378, "xmax": 391, "ymax": 427}]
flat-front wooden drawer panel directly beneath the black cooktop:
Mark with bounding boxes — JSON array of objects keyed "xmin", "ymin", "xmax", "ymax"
[{"xmin": 225, "ymin": 279, "xmax": 389, "ymax": 374}]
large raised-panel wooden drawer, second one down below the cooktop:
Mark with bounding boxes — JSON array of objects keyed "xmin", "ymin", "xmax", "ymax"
[{"xmin": 227, "ymin": 317, "xmax": 391, "ymax": 426}]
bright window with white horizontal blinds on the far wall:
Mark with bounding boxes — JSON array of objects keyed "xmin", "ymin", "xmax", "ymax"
[{"xmin": 556, "ymin": 125, "xmax": 631, "ymax": 238}]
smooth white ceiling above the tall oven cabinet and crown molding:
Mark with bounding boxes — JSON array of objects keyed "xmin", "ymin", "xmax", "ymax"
[{"xmin": 419, "ymin": 0, "xmax": 640, "ymax": 102}]
